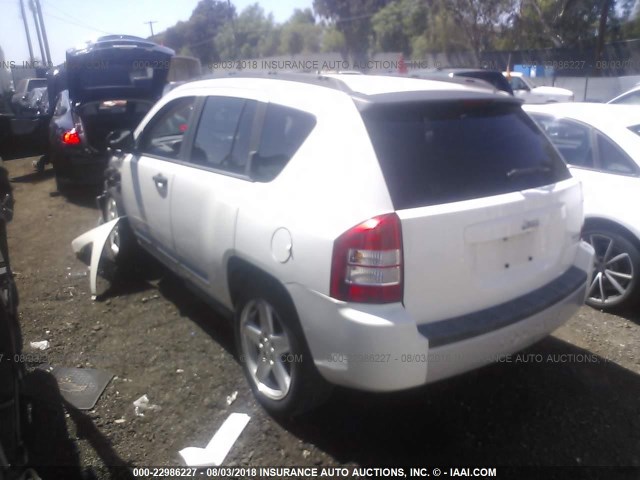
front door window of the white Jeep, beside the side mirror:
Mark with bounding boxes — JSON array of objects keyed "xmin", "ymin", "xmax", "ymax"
[{"xmin": 139, "ymin": 97, "xmax": 195, "ymax": 159}]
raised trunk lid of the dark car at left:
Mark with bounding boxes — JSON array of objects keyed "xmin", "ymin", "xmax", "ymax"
[{"xmin": 64, "ymin": 35, "xmax": 174, "ymax": 103}]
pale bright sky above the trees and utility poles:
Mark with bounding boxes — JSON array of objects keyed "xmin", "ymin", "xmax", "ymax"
[{"xmin": 0, "ymin": 0, "xmax": 312, "ymax": 64}]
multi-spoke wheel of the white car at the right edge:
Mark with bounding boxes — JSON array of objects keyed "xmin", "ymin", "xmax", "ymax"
[{"xmin": 583, "ymin": 229, "xmax": 640, "ymax": 310}]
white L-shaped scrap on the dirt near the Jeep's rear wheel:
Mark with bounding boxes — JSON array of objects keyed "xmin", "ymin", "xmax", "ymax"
[{"xmin": 178, "ymin": 413, "xmax": 251, "ymax": 467}]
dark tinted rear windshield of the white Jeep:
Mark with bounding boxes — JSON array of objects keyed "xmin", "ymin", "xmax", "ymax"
[{"xmin": 363, "ymin": 102, "xmax": 570, "ymax": 209}]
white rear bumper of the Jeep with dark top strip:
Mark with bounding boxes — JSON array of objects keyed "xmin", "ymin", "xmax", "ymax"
[{"xmin": 288, "ymin": 242, "xmax": 593, "ymax": 391}]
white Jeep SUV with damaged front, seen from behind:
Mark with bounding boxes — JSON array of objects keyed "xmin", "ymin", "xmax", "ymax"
[{"xmin": 97, "ymin": 74, "xmax": 593, "ymax": 414}]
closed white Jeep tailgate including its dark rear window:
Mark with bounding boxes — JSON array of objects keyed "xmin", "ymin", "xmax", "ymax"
[{"xmin": 363, "ymin": 97, "xmax": 582, "ymax": 324}]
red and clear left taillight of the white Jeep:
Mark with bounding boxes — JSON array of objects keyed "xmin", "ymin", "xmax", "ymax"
[{"xmin": 331, "ymin": 213, "xmax": 403, "ymax": 303}]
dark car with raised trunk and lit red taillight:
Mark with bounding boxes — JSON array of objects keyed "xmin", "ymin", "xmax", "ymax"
[{"xmin": 48, "ymin": 35, "xmax": 174, "ymax": 191}]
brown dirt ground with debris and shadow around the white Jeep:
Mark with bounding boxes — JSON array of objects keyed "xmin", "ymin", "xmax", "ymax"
[{"xmin": 5, "ymin": 158, "xmax": 640, "ymax": 478}]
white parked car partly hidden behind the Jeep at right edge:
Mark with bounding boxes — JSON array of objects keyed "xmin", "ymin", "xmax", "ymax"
[{"xmin": 525, "ymin": 103, "xmax": 640, "ymax": 309}]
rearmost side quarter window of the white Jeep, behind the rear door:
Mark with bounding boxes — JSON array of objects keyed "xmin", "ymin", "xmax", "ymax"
[{"xmin": 251, "ymin": 103, "xmax": 316, "ymax": 182}]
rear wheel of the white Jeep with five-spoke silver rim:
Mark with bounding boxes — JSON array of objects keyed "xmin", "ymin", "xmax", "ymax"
[{"xmin": 235, "ymin": 281, "xmax": 331, "ymax": 417}]
